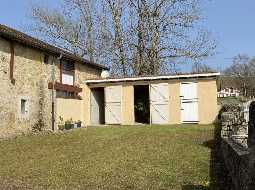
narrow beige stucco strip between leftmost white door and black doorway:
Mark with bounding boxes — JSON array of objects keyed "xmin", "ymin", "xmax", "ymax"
[{"xmin": 122, "ymin": 85, "xmax": 135, "ymax": 125}]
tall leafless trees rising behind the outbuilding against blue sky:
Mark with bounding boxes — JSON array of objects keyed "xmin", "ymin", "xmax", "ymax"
[{"xmin": 28, "ymin": 0, "xmax": 215, "ymax": 75}]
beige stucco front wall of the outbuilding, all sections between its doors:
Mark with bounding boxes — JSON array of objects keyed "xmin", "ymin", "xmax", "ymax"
[{"xmin": 85, "ymin": 79, "xmax": 218, "ymax": 125}]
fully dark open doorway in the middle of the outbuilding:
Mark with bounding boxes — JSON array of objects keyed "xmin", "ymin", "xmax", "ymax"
[{"xmin": 134, "ymin": 85, "xmax": 150, "ymax": 124}]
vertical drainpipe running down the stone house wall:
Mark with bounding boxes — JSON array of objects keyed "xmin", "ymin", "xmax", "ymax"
[{"xmin": 51, "ymin": 53, "xmax": 63, "ymax": 131}]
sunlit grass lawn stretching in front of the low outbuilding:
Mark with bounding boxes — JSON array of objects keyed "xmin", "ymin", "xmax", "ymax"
[{"xmin": 0, "ymin": 125, "xmax": 218, "ymax": 190}]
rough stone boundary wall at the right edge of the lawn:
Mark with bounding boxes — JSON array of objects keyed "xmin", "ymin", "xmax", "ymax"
[{"xmin": 220, "ymin": 102, "xmax": 255, "ymax": 190}]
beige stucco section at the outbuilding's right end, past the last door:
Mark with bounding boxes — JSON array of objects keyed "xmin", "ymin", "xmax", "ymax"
[{"xmin": 198, "ymin": 79, "xmax": 218, "ymax": 124}]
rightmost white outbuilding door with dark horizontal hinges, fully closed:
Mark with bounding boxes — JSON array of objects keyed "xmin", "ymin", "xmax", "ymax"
[{"xmin": 181, "ymin": 82, "xmax": 198, "ymax": 123}]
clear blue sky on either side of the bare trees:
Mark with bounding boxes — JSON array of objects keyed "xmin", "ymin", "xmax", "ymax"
[{"xmin": 0, "ymin": 0, "xmax": 255, "ymax": 70}]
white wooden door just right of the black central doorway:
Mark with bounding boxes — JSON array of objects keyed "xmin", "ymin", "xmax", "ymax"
[{"xmin": 150, "ymin": 83, "xmax": 169, "ymax": 124}]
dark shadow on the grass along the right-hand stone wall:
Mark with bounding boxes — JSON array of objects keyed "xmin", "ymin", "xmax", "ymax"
[{"xmin": 182, "ymin": 125, "xmax": 231, "ymax": 190}]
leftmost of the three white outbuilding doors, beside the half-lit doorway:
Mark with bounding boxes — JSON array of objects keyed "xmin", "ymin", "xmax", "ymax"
[{"xmin": 105, "ymin": 86, "xmax": 122, "ymax": 124}]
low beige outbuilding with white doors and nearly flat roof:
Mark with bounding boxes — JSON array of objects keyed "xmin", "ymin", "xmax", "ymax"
[{"xmin": 84, "ymin": 73, "xmax": 219, "ymax": 125}]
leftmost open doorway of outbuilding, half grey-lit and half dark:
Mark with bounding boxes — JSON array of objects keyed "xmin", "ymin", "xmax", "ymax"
[{"xmin": 90, "ymin": 88, "xmax": 105, "ymax": 125}]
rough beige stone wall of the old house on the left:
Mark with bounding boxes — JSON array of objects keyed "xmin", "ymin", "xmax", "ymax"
[{"xmin": 0, "ymin": 38, "xmax": 101, "ymax": 134}]
